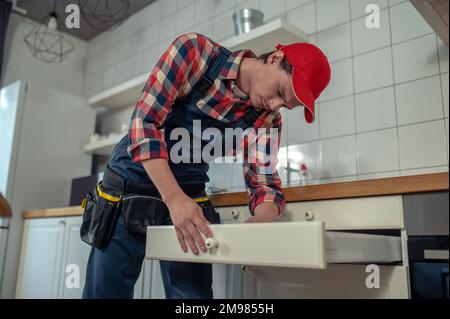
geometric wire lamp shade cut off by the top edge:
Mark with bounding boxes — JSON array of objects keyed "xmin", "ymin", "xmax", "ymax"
[{"xmin": 78, "ymin": 0, "xmax": 130, "ymax": 31}]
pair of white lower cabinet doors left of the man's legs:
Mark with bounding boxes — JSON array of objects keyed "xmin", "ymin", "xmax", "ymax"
[{"xmin": 16, "ymin": 217, "xmax": 90, "ymax": 299}]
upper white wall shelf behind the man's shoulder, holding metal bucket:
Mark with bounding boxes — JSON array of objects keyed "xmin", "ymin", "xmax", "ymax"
[{"xmin": 88, "ymin": 18, "xmax": 308, "ymax": 110}]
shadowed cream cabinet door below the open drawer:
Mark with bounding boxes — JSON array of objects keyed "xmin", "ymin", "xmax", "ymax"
[{"xmin": 243, "ymin": 264, "xmax": 409, "ymax": 299}]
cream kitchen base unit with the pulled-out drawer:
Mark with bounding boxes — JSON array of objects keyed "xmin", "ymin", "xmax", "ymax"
[{"xmin": 146, "ymin": 195, "xmax": 410, "ymax": 298}]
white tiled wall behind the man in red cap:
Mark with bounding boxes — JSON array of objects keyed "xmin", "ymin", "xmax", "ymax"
[{"xmin": 72, "ymin": 0, "xmax": 449, "ymax": 190}]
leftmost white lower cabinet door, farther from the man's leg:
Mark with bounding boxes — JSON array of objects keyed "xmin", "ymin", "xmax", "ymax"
[{"xmin": 16, "ymin": 218, "xmax": 65, "ymax": 298}]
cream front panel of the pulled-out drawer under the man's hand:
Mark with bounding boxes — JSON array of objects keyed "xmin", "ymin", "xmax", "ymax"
[{"xmin": 146, "ymin": 222, "xmax": 326, "ymax": 269}]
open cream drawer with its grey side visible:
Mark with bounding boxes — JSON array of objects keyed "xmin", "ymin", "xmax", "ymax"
[{"xmin": 146, "ymin": 221, "xmax": 402, "ymax": 269}]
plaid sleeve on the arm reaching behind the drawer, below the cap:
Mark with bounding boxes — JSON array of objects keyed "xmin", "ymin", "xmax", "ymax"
[{"xmin": 243, "ymin": 115, "xmax": 285, "ymax": 216}]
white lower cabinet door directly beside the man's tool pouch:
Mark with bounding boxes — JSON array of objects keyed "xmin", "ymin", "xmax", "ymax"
[{"xmin": 59, "ymin": 217, "xmax": 91, "ymax": 299}]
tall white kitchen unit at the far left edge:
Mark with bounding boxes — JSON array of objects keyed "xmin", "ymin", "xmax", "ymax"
[{"xmin": 0, "ymin": 81, "xmax": 95, "ymax": 298}]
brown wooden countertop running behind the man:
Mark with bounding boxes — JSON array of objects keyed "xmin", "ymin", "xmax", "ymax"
[{"xmin": 22, "ymin": 173, "xmax": 449, "ymax": 218}]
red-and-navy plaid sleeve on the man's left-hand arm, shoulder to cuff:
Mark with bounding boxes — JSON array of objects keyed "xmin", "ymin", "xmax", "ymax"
[{"xmin": 127, "ymin": 33, "xmax": 216, "ymax": 162}]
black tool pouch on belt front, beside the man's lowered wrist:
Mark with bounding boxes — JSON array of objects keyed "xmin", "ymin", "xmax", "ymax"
[{"xmin": 121, "ymin": 194, "xmax": 170, "ymax": 234}]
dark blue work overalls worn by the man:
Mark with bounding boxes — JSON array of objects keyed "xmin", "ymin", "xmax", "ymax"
[{"xmin": 83, "ymin": 48, "xmax": 252, "ymax": 299}]
